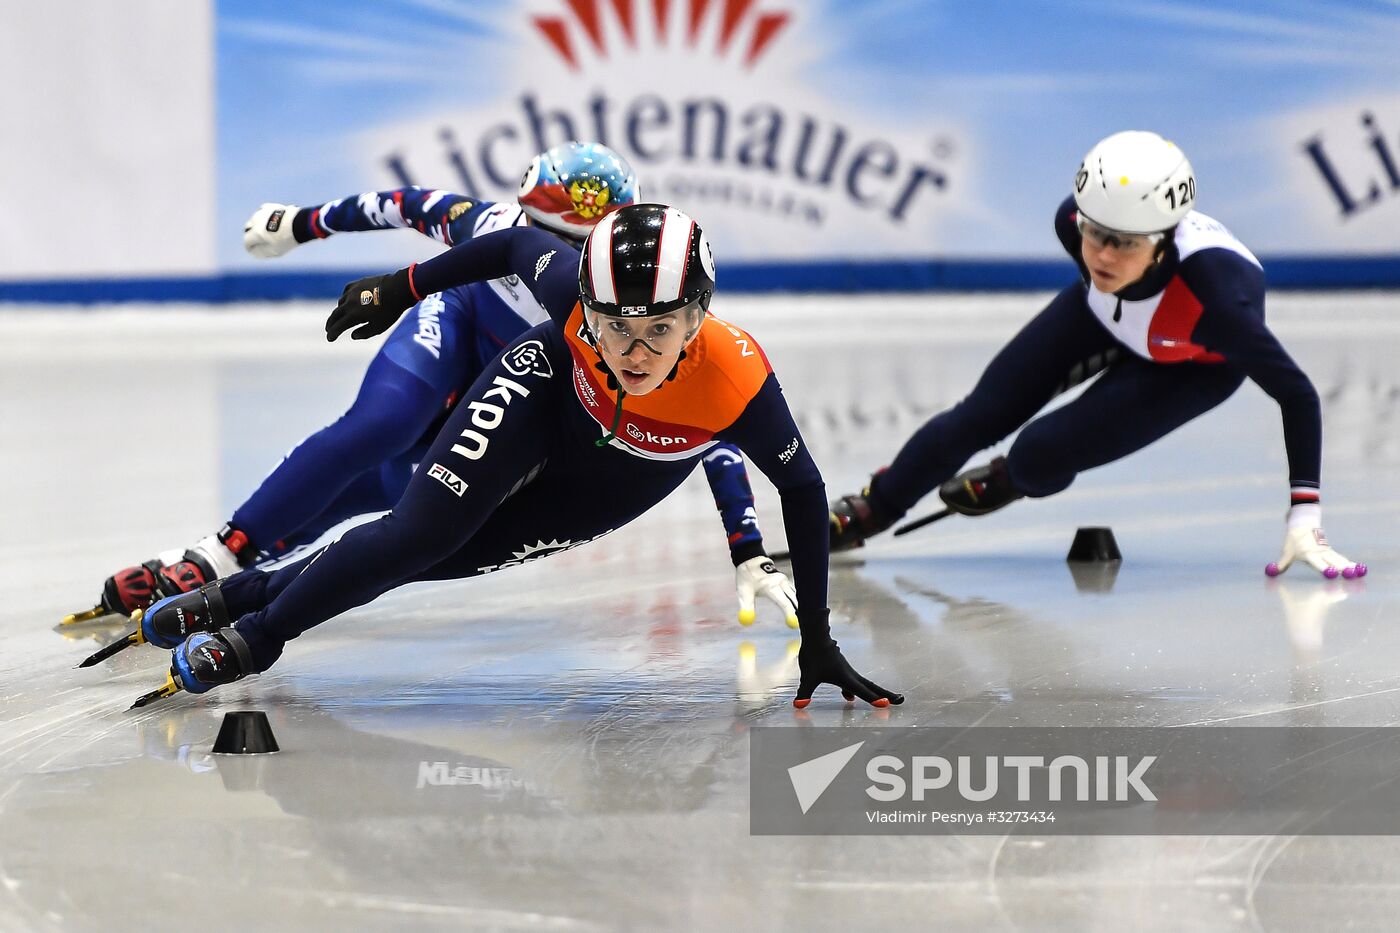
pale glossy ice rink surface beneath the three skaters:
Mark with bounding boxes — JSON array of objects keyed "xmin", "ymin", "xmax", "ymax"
[{"xmin": 0, "ymin": 293, "xmax": 1400, "ymax": 933}]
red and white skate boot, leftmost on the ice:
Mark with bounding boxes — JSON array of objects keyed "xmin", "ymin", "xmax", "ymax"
[{"xmin": 63, "ymin": 525, "xmax": 256, "ymax": 625}]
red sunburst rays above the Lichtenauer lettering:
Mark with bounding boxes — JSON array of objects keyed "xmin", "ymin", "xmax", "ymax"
[{"xmin": 532, "ymin": 0, "xmax": 791, "ymax": 71}]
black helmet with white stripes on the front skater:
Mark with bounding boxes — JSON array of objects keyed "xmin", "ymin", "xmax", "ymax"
[{"xmin": 578, "ymin": 205, "xmax": 714, "ymax": 318}]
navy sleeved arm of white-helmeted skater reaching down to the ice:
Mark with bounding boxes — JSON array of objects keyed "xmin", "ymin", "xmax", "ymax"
[{"xmin": 1180, "ymin": 249, "xmax": 1322, "ymax": 488}]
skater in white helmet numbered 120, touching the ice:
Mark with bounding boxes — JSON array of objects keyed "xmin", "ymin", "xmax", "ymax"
[{"xmin": 832, "ymin": 130, "xmax": 1366, "ymax": 579}]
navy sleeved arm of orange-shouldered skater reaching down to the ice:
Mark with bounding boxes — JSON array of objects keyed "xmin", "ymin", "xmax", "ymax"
[{"xmin": 720, "ymin": 373, "xmax": 830, "ymax": 642}]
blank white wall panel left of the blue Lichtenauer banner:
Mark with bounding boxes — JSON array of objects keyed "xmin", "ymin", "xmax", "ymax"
[{"xmin": 0, "ymin": 0, "xmax": 217, "ymax": 280}]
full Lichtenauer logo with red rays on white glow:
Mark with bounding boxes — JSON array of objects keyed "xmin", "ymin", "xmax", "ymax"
[{"xmin": 377, "ymin": 0, "xmax": 966, "ymax": 262}]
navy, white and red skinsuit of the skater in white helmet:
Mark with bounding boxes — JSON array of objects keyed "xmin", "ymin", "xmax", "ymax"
[{"xmin": 872, "ymin": 199, "xmax": 1322, "ymax": 518}]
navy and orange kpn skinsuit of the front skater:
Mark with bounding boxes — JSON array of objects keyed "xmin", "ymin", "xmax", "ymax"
[{"xmin": 223, "ymin": 227, "xmax": 827, "ymax": 671}]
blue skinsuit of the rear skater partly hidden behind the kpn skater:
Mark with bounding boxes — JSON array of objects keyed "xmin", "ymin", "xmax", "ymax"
[{"xmin": 231, "ymin": 188, "xmax": 763, "ymax": 554}]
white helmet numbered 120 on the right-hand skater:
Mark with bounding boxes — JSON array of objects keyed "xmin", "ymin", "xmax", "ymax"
[{"xmin": 1074, "ymin": 130, "xmax": 1196, "ymax": 234}]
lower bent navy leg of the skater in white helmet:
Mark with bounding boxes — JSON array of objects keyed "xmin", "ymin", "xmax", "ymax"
[{"xmin": 1007, "ymin": 357, "xmax": 1245, "ymax": 497}]
